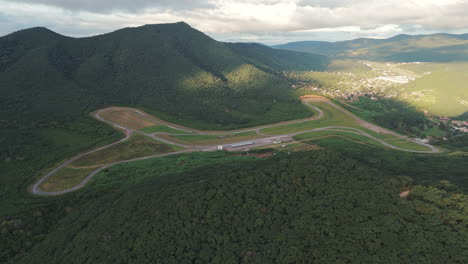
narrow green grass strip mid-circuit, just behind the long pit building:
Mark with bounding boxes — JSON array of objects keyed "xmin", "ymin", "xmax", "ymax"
[{"xmin": 161, "ymin": 131, "xmax": 263, "ymax": 145}]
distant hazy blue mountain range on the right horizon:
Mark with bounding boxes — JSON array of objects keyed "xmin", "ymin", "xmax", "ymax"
[{"xmin": 275, "ymin": 34, "xmax": 468, "ymax": 62}]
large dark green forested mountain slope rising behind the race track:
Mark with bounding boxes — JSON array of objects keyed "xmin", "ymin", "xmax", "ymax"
[{"xmin": 0, "ymin": 23, "xmax": 328, "ymax": 215}]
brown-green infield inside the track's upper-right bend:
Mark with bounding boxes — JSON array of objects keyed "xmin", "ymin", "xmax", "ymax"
[{"xmin": 260, "ymin": 102, "xmax": 362, "ymax": 135}]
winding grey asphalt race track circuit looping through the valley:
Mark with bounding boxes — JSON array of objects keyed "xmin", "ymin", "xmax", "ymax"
[{"xmin": 30, "ymin": 99, "xmax": 440, "ymax": 196}]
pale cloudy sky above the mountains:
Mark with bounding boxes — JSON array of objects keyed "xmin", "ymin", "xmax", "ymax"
[{"xmin": 0, "ymin": 0, "xmax": 468, "ymax": 44}]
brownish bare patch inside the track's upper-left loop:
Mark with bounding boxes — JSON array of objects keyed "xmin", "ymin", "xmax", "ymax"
[{"xmin": 100, "ymin": 109, "xmax": 157, "ymax": 130}]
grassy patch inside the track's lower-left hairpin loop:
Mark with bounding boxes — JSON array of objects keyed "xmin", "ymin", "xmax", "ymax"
[{"xmin": 40, "ymin": 167, "xmax": 95, "ymax": 192}]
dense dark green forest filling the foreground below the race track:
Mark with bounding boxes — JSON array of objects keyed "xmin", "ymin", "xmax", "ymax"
[{"xmin": 4, "ymin": 147, "xmax": 468, "ymax": 263}]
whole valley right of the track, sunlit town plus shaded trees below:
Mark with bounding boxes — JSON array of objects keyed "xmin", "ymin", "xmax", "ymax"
[{"xmin": 288, "ymin": 60, "xmax": 468, "ymax": 149}]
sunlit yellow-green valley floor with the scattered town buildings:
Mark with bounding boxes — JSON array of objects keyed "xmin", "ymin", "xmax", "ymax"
[{"xmin": 290, "ymin": 60, "xmax": 468, "ymax": 117}]
